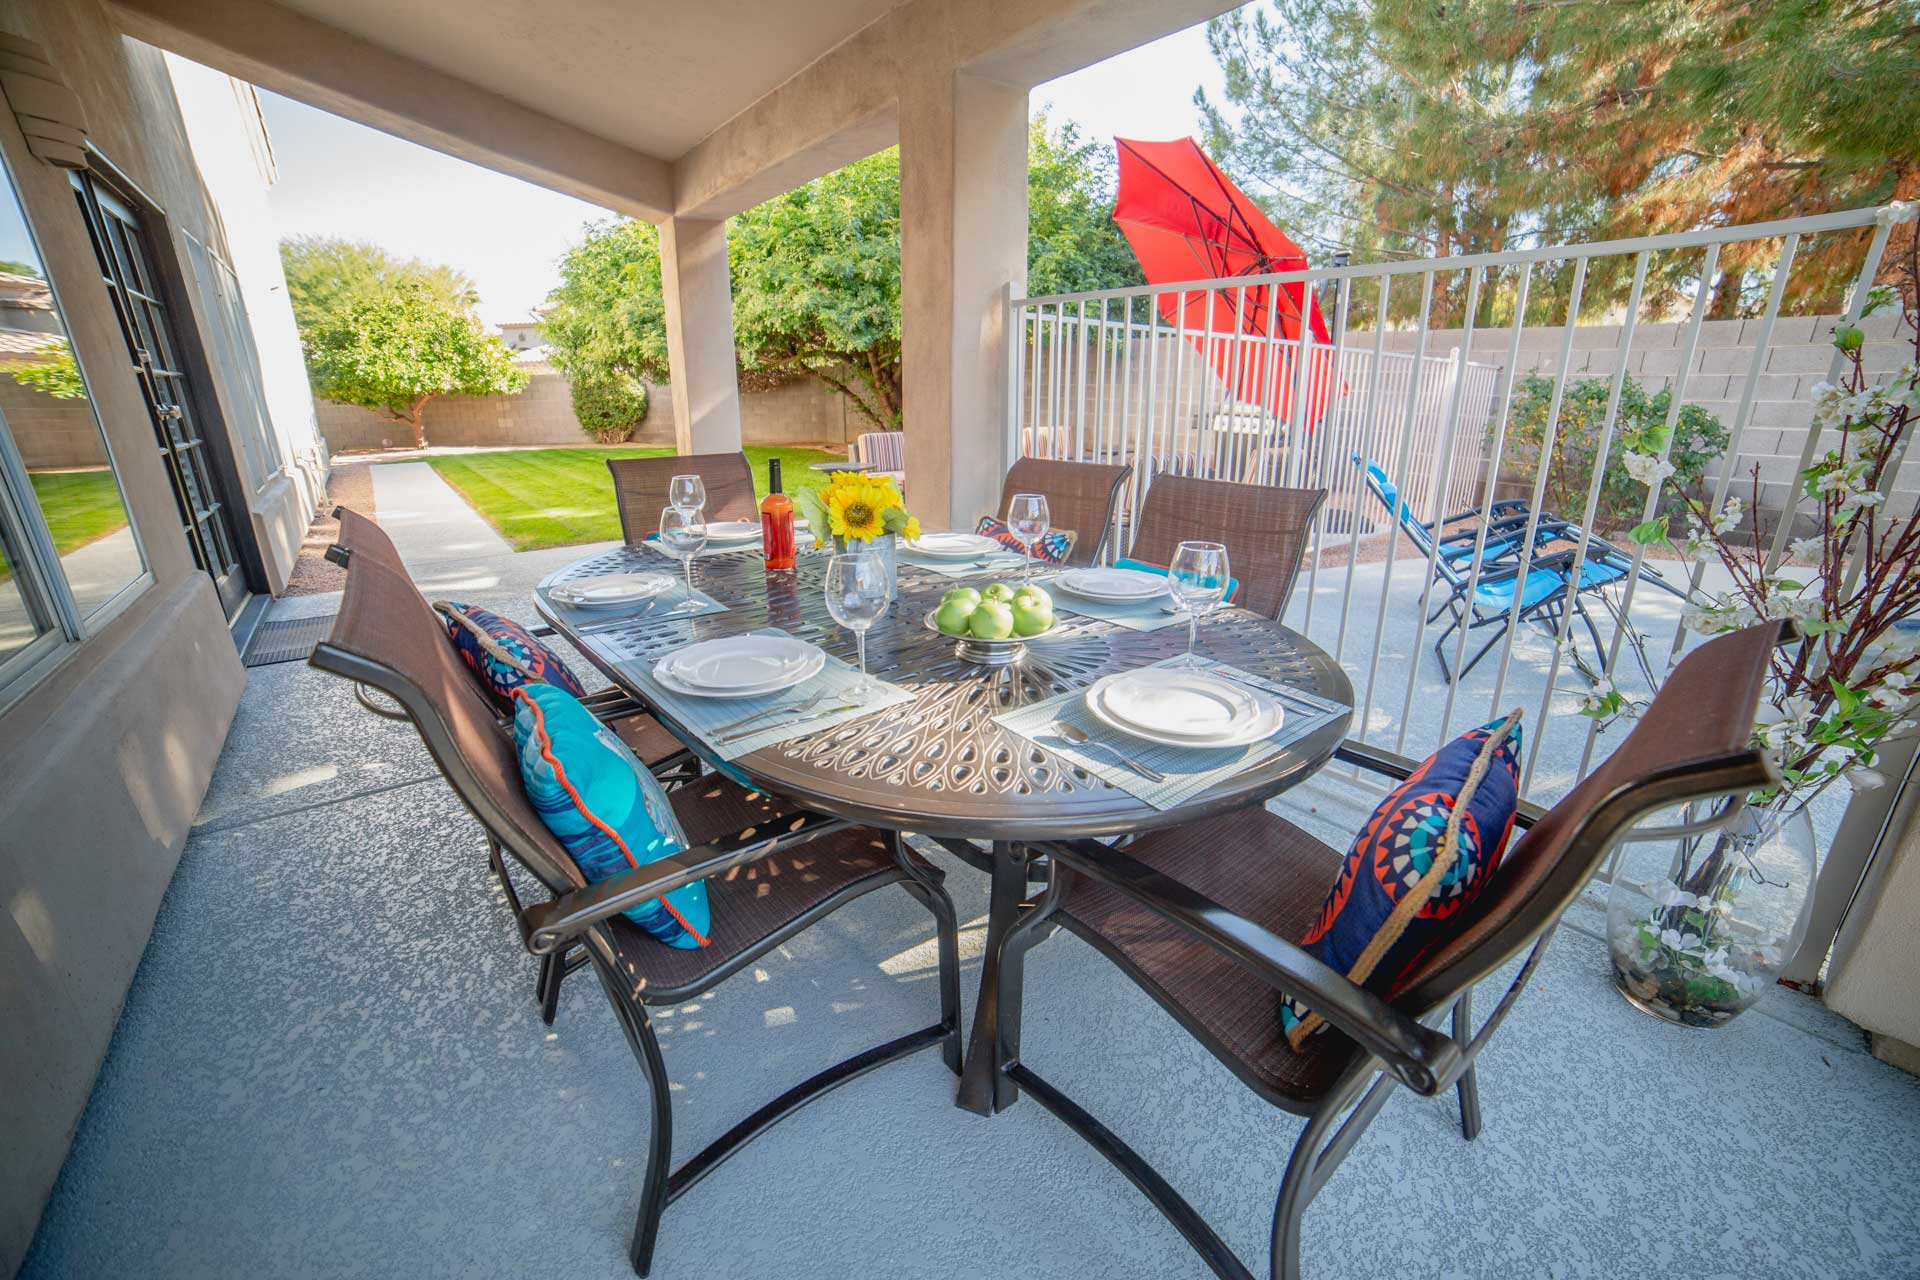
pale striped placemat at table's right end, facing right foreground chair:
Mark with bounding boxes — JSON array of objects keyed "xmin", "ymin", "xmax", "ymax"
[{"xmin": 995, "ymin": 656, "xmax": 1350, "ymax": 810}]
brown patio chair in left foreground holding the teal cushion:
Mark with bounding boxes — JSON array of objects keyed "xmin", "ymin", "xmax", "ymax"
[{"xmin": 311, "ymin": 557, "xmax": 960, "ymax": 1276}]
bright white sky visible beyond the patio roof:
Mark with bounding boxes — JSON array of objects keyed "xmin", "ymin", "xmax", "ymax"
[{"xmin": 259, "ymin": 18, "xmax": 1221, "ymax": 324}]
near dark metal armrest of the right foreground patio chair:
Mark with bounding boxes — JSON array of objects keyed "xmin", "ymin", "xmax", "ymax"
[{"xmin": 1035, "ymin": 841, "xmax": 1463, "ymax": 1096}]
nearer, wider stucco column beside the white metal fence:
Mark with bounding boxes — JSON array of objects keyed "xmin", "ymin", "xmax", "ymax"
[{"xmin": 900, "ymin": 71, "xmax": 1027, "ymax": 530}]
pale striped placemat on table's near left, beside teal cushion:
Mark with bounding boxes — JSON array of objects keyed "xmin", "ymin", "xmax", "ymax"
[{"xmin": 618, "ymin": 628, "xmax": 914, "ymax": 760}]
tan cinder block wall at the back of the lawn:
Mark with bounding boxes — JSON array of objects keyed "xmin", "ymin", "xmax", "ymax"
[{"xmin": 312, "ymin": 365, "xmax": 868, "ymax": 453}]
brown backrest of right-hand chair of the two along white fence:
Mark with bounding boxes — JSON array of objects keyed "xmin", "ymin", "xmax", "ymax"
[{"xmin": 1127, "ymin": 476, "xmax": 1327, "ymax": 618}]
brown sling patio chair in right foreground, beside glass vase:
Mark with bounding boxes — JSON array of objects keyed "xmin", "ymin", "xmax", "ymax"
[{"xmin": 981, "ymin": 624, "xmax": 1793, "ymax": 1280}]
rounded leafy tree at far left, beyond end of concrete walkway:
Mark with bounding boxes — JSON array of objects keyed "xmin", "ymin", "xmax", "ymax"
[{"xmin": 300, "ymin": 282, "xmax": 528, "ymax": 447}]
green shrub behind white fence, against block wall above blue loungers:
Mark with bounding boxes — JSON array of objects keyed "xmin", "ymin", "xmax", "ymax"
[{"xmin": 1488, "ymin": 372, "xmax": 1726, "ymax": 532}]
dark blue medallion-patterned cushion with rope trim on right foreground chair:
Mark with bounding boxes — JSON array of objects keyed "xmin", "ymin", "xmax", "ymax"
[{"xmin": 1281, "ymin": 708, "xmax": 1521, "ymax": 1050}]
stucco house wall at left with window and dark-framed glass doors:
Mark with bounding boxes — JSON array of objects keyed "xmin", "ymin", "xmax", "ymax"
[{"xmin": 0, "ymin": 17, "xmax": 326, "ymax": 1274}]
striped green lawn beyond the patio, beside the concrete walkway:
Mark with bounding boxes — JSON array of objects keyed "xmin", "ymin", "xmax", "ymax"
[{"xmin": 426, "ymin": 447, "xmax": 839, "ymax": 551}]
